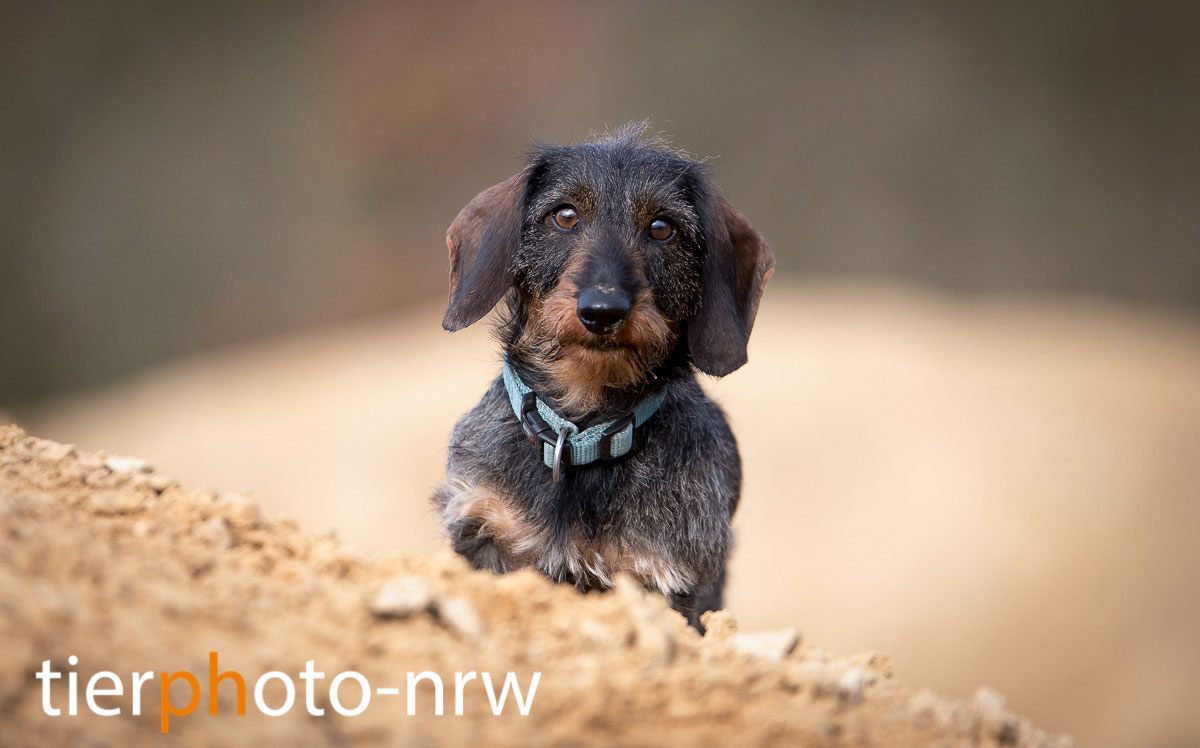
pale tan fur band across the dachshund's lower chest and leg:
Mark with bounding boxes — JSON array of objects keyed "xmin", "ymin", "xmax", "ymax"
[{"xmin": 443, "ymin": 481, "xmax": 695, "ymax": 593}]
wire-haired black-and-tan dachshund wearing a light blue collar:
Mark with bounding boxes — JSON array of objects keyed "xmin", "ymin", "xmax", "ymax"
[{"xmin": 433, "ymin": 124, "xmax": 775, "ymax": 632}]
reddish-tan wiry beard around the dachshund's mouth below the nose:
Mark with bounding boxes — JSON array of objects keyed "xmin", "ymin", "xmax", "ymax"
[{"xmin": 520, "ymin": 283, "xmax": 674, "ymax": 413}]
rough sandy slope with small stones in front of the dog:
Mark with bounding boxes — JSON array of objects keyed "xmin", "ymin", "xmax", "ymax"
[{"xmin": 0, "ymin": 426, "xmax": 1069, "ymax": 746}]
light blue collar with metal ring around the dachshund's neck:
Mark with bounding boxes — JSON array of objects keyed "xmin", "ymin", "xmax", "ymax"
[{"xmin": 504, "ymin": 358, "xmax": 666, "ymax": 483}]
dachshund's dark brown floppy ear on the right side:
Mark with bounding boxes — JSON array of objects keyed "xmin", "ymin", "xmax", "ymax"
[{"xmin": 688, "ymin": 195, "xmax": 775, "ymax": 377}]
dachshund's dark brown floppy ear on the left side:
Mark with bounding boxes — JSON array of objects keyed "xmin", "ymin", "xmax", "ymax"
[{"xmin": 442, "ymin": 169, "xmax": 528, "ymax": 333}]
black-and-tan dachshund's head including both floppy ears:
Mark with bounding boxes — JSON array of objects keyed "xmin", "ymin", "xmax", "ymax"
[{"xmin": 442, "ymin": 127, "xmax": 775, "ymax": 405}]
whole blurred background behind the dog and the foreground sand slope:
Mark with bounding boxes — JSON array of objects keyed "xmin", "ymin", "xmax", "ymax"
[{"xmin": 0, "ymin": 0, "xmax": 1200, "ymax": 747}]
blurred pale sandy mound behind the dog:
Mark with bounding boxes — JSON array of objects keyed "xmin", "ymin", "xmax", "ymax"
[{"xmin": 25, "ymin": 277, "xmax": 1200, "ymax": 748}]
